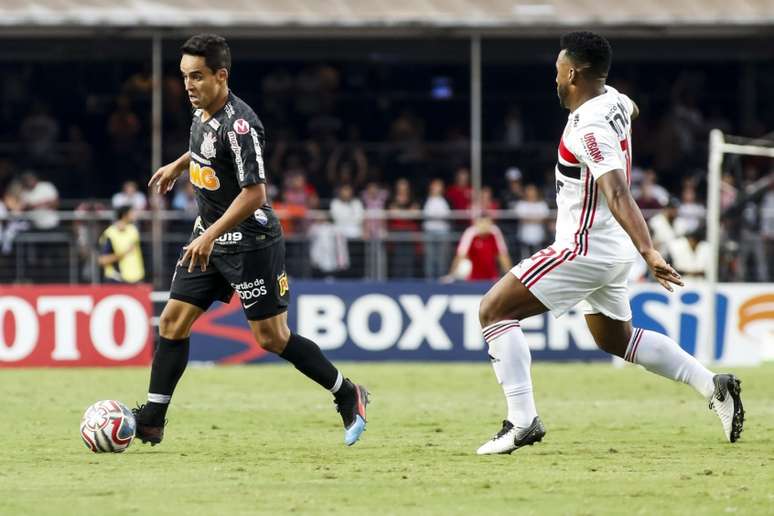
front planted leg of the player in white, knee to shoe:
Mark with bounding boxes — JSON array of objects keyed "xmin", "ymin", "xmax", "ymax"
[{"xmin": 477, "ymin": 272, "xmax": 547, "ymax": 455}]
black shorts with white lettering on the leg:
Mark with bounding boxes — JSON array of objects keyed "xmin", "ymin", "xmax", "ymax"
[{"xmin": 169, "ymin": 240, "xmax": 290, "ymax": 321}]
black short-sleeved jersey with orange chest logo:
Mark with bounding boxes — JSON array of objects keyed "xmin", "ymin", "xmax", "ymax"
[{"xmin": 188, "ymin": 92, "xmax": 282, "ymax": 254}]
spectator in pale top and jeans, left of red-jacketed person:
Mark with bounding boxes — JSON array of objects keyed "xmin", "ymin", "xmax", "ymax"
[{"xmin": 422, "ymin": 179, "xmax": 451, "ymax": 279}]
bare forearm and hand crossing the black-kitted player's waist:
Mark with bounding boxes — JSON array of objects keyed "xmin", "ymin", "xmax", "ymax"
[{"xmin": 180, "ymin": 183, "xmax": 266, "ymax": 272}]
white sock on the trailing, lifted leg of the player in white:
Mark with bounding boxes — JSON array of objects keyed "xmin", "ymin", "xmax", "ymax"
[{"xmin": 624, "ymin": 328, "xmax": 715, "ymax": 399}]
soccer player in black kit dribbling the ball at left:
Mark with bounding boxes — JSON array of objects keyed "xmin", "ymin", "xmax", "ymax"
[{"xmin": 134, "ymin": 34, "xmax": 368, "ymax": 446}]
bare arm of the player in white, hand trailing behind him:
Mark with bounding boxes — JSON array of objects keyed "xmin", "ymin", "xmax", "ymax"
[{"xmin": 597, "ymin": 170, "xmax": 683, "ymax": 292}]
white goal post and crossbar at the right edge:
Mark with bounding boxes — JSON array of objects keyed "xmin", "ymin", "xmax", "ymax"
[{"xmin": 698, "ymin": 129, "xmax": 774, "ymax": 363}]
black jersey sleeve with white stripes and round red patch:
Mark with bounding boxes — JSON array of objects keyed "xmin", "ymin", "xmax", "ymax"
[{"xmin": 225, "ymin": 118, "xmax": 266, "ymax": 188}]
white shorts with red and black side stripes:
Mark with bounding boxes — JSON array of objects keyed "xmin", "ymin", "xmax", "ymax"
[{"xmin": 511, "ymin": 247, "xmax": 632, "ymax": 321}]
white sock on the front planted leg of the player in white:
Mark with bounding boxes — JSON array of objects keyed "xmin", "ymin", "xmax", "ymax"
[{"xmin": 482, "ymin": 320, "xmax": 537, "ymax": 428}]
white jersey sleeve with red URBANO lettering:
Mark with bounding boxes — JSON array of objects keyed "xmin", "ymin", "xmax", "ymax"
[{"xmin": 570, "ymin": 123, "xmax": 626, "ymax": 180}]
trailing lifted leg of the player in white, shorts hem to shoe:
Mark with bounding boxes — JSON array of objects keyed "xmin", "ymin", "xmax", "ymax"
[{"xmin": 586, "ymin": 270, "xmax": 744, "ymax": 442}]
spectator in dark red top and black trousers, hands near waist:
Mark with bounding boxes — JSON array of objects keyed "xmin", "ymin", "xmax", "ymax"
[{"xmin": 387, "ymin": 178, "xmax": 421, "ymax": 278}]
